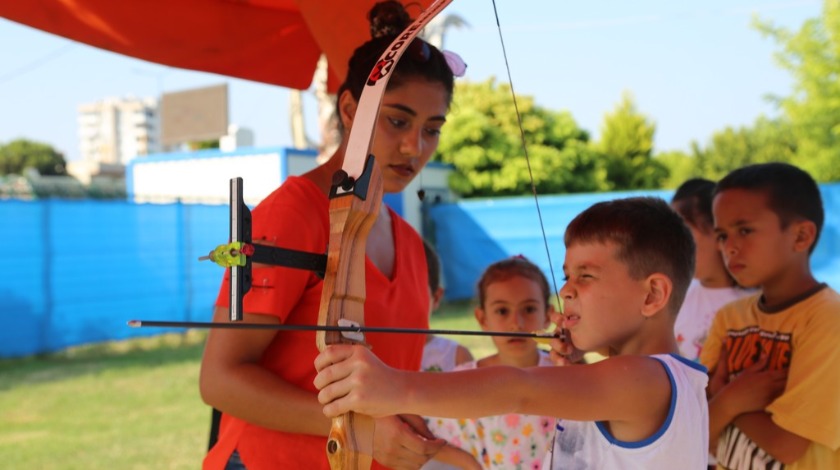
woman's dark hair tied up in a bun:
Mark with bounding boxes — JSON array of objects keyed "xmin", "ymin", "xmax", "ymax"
[{"xmin": 336, "ymin": 0, "xmax": 455, "ymax": 131}]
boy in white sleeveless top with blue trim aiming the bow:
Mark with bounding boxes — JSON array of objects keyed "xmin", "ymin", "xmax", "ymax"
[{"xmin": 314, "ymin": 198, "xmax": 708, "ymax": 469}]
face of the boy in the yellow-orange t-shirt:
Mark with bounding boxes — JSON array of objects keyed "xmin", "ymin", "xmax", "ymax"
[{"xmin": 712, "ymin": 189, "xmax": 797, "ymax": 287}]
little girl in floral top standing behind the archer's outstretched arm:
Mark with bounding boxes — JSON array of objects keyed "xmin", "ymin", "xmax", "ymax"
[{"xmin": 423, "ymin": 256, "xmax": 554, "ymax": 470}]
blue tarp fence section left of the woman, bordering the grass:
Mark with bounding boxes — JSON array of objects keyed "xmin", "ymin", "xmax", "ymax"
[{"xmin": 0, "ymin": 200, "xmax": 229, "ymax": 357}]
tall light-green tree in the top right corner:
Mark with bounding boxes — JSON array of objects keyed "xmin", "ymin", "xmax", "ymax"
[{"xmin": 753, "ymin": 0, "xmax": 840, "ymax": 181}]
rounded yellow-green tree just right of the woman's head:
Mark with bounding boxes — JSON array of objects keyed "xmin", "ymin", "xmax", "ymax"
[{"xmin": 436, "ymin": 78, "xmax": 606, "ymax": 197}]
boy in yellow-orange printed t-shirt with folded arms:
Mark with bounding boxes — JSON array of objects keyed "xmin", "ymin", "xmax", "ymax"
[{"xmin": 700, "ymin": 163, "xmax": 840, "ymax": 469}]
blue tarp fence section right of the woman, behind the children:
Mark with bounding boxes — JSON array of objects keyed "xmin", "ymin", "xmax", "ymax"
[{"xmin": 429, "ymin": 184, "xmax": 840, "ymax": 300}]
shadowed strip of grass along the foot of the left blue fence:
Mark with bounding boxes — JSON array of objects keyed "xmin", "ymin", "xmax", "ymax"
[{"xmin": 0, "ymin": 331, "xmax": 206, "ymax": 391}]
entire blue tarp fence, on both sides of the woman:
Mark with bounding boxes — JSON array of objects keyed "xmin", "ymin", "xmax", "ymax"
[{"xmin": 0, "ymin": 184, "xmax": 840, "ymax": 358}]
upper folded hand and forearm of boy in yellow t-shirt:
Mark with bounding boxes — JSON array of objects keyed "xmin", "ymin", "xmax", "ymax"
[{"xmin": 721, "ymin": 354, "xmax": 787, "ymax": 414}]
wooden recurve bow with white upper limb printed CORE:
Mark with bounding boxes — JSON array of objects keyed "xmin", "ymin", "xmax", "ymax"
[{"xmin": 316, "ymin": 0, "xmax": 452, "ymax": 470}]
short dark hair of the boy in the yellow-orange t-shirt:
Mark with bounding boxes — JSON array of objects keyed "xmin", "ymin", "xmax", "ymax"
[{"xmin": 715, "ymin": 162, "xmax": 825, "ymax": 253}]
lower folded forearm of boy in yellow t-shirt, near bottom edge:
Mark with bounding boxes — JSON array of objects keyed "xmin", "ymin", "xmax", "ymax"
[{"xmin": 734, "ymin": 411, "xmax": 811, "ymax": 464}]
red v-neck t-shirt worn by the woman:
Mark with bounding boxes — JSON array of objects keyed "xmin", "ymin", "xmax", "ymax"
[{"xmin": 204, "ymin": 177, "xmax": 429, "ymax": 470}]
